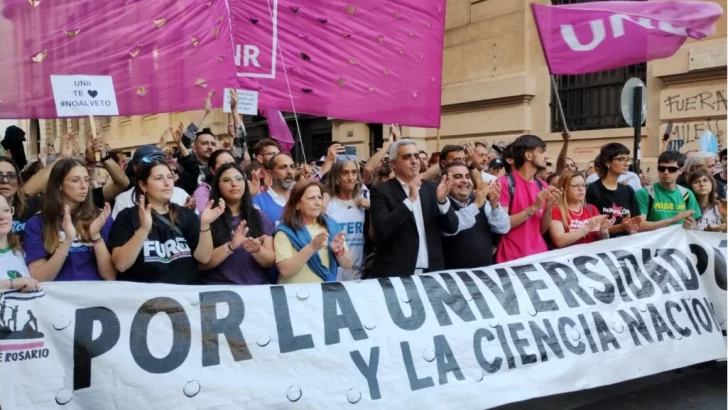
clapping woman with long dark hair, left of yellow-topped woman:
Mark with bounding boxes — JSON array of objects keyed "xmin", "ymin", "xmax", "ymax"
[{"xmin": 200, "ymin": 163, "xmax": 276, "ymax": 285}]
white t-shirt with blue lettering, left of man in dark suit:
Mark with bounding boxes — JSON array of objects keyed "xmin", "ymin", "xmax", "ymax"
[{"xmin": 326, "ymin": 191, "xmax": 368, "ymax": 281}]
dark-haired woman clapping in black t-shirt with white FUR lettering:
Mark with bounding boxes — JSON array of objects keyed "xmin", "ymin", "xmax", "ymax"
[{"xmin": 109, "ymin": 159, "xmax": 225, "ymax": 285}]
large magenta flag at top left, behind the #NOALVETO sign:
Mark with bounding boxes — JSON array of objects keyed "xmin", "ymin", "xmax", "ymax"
[{"xmin": 0, "ymin": 0, "xmax": 236, "ymax": 118}]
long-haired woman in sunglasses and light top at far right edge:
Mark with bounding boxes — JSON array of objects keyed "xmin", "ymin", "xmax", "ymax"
[{"xmin": 687, "ymin": 169, "xmax": 726, "ymax": 232}]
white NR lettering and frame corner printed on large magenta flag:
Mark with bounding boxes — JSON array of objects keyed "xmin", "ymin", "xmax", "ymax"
[{"xmin": 235, "ymin": 0, "xmax": 278, "ymax": 79}]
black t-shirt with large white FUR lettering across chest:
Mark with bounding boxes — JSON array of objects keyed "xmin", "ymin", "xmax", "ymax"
[{"xmin": 108, "ymin": 204, "xmax": 200, "ymax": 285}]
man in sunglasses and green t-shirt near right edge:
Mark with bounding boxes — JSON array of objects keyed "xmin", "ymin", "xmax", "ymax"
[{"xmin": 637, "ymin": 151, "xmax": 702, "ymax": 231}]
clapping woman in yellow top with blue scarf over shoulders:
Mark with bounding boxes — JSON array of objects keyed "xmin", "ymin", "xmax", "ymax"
[{"xmin": 274, "ymin": 180, "xmax": 352, "ymax": 284}]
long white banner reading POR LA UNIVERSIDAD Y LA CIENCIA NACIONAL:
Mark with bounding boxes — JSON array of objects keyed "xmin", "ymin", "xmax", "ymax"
[{"xmin": 0, "ymin": 228, "xmax": 726, "ymax": 410}]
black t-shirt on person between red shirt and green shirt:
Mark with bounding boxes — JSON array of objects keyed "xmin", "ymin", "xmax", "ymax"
[{"xmin": 586, "ymin": 181, "xmax": 640, "ymax": 237}]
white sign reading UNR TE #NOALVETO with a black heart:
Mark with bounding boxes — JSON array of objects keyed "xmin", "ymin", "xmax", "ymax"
[{"xmin": 51, "ymin": 75, "xmax": 119, "ymax": 117}]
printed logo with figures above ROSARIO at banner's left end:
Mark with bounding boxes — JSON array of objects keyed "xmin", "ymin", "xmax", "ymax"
[{"xmin": 0, "ymin": 291, "xmax": 49, "ymax": 366}]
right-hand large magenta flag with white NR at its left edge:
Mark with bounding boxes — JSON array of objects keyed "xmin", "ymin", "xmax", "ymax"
[{"xmin": 230, "ymin": 0, "xmax": 445, "ymax": 127}]
